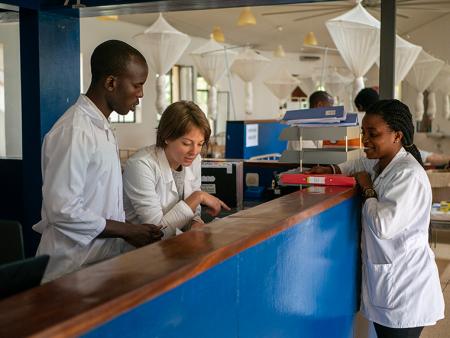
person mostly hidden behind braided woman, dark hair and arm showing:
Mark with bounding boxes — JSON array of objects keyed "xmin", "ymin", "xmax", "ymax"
[{"xmin": 355, "ymin": 88, "xmax": 450, "ymax": 167}]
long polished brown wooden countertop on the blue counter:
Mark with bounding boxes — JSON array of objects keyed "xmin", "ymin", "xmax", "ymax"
[{"xmin": 0, "ymin": 187, "xmax": 355, "ymax": 337}]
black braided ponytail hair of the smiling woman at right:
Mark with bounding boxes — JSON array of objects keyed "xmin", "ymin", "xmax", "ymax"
[{"xmin": 366, "ymin": 100, "xmax": 423, "ymax": 166}]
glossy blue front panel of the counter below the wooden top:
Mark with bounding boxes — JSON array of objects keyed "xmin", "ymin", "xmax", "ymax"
[{"xmin": 85, "ymin": 198, "xmax": 360, "ymax": 338}]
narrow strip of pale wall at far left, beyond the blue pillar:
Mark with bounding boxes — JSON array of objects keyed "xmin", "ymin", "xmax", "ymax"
[{"xmin": 0, "ymin": 23, "xmax": 22, "ymax": 158}]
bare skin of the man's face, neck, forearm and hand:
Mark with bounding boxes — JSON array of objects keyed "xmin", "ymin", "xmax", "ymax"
[{"xmin": 86, "ymin": 56, "xmax": 163, "ymax": 247}]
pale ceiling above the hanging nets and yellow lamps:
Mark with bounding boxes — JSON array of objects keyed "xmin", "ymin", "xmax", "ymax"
[{"xmin": 119, "ymin": 0, "xmax": 450, "ymax": 52}]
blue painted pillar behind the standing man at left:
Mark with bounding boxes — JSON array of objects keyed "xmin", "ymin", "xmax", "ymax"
[{"xmin": 20, "ymin": 8, "xmax": 80, "ymax": 255}]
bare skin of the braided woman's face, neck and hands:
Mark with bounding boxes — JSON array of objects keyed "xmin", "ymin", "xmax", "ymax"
[{"xmin": 308, "ymin": 115, "xmax": 403, "ymax": 190}]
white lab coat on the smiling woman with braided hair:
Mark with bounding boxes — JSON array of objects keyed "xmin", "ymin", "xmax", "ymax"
[{"xmin": 340, "ymin": 148, "xmax": 444, "ymax": 328}]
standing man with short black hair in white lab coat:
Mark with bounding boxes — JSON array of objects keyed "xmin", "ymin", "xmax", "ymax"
[{"xmin": 33, "ymin": 40, "xmax": 162, "ymax": 282}]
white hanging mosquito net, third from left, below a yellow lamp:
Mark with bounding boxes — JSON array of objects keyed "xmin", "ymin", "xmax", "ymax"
[{"xmin": 231, "ymin": 48, "xmax": 270, "ymax": 114}]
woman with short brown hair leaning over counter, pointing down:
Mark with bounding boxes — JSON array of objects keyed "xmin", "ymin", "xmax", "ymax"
[{"xmin": 123, "ymin": 101, "xmax": 230, "ymax": 239}]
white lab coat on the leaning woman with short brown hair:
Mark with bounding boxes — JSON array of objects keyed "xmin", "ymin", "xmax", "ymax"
[{"xmin": 123, "ymin": 145, "xmax": 201, "ymax": 239}]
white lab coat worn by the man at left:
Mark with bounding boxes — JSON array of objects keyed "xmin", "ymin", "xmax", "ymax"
[{"xmin": 33, "ymin": 95, "xmax": 125, "ymax": 281}]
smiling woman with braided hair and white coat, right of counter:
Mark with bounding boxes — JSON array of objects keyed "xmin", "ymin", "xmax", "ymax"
[{"xmin": 310, "ymin": 100, "xmax": 444, "ymax": 338}]
